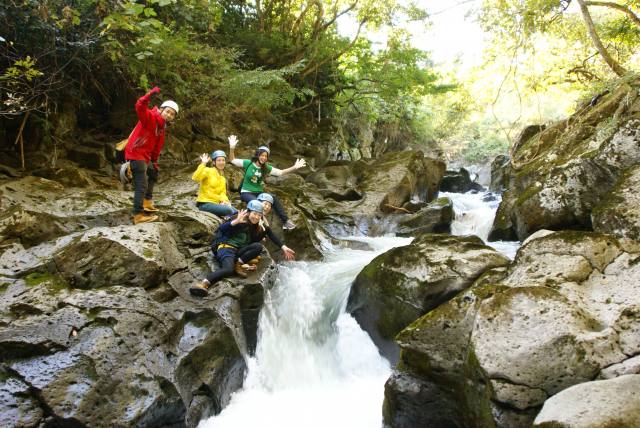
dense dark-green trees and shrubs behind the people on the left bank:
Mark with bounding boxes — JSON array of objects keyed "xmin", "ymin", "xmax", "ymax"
[{"xmin": 0, "ymin": 0, "xmax": 454, "ymax": 160}]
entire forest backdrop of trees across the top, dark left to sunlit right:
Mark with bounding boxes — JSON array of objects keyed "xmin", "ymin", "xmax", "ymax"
[{"xmin": 0, "ymin": 0, "xmax": 640, "ymax": 166}]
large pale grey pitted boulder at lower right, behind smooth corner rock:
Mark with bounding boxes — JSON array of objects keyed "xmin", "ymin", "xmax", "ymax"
[{"xmin": 385, "ymin": 232, "xmax": 640, "ymax": 427}]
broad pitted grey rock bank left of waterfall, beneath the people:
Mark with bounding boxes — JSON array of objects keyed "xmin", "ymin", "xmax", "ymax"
[{"xmin": 0, "ymin": 177, "xmax": 275, "ymax": 427}]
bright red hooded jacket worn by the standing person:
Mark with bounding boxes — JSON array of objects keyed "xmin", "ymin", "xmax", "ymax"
[{"xmin": 124, "ymin": 92, "xmax": 166, "ymax": 164}]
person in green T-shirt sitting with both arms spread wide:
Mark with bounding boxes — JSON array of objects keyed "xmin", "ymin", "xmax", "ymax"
[{"xmin": 229, "ymin": 135, "xmax": 307, "ymax": 230}]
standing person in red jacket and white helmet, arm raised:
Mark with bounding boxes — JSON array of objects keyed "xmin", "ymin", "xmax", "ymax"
[{"xmin": 124, "ymin": 86, "xmax": 180, "ymax": 224}]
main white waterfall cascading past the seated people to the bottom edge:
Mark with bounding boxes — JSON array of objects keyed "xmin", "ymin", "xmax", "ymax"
[{"xmin": 199, "ymin": 237, "xmax": 411, "ymax": 428}]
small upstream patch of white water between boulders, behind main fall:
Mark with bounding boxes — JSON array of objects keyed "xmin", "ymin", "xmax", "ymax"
[{"xmin": 438, "ymin": 192, "xmax": 520, "ymax": 260}]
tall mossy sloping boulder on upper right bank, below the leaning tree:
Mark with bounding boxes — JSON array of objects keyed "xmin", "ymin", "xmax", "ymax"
[{"xmin": 492, "ymin": 82, "xmax": 640, "ymax": 240}]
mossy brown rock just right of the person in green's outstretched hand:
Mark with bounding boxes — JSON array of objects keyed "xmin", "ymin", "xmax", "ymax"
[{"xmin": 300, "ymin": 151, "xmax": 444, "ymax": 235}]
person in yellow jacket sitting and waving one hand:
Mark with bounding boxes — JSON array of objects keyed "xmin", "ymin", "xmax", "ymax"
[{"xmin": 191, "ymin": 150, "xmax": 238, "ymax": 217}]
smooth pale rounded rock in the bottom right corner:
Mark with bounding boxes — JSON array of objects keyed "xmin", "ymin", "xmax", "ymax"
[{"xmin": 533, "ymin": 375, "xmax": 640, "ymax": 428}]
